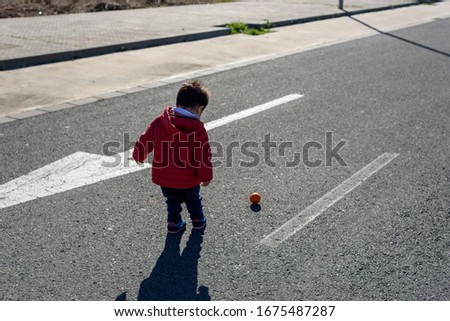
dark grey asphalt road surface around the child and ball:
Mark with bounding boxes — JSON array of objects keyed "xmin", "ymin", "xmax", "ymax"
[{"xmin": 0, "ymin": 19, "xmax": 450, "ymax": 300}]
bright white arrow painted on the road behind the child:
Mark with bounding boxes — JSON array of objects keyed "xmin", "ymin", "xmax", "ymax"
[{"xmin": 0, "ymin": 94, "xmax": 303, "ymax": 208}]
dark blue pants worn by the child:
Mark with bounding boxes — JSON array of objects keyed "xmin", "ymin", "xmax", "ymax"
[{"xmin": 161, "ymin": 185, "xmax": 203, "ymax": 223}]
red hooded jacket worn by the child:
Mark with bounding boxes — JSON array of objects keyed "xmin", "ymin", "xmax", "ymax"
[{"xmin": 133, "ymin": 107, "xmax": 213, "ymax": 188}]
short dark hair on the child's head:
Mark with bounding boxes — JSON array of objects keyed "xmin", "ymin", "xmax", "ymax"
[{"xmin": 177, "ymin": 80, "xmax": 211, "ymax": 108}]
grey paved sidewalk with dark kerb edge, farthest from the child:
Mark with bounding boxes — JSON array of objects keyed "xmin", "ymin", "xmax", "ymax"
[{"xmin": 0, "ymin": 0, "xmax": 417, "ymax": 70}]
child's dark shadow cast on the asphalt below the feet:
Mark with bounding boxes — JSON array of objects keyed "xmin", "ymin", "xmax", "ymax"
[{"xmin": 138, "ymin": 230, "xmax": 211, "ymax": 301}]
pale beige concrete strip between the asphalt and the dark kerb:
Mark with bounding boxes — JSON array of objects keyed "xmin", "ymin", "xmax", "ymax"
[{"xmin": 0, "ymin": 2, "xmax": 450, "ymax": 124}]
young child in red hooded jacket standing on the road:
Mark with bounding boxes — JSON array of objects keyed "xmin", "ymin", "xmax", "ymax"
[{"xmin": 133, "ymin": 80, "xmax": 213, "ymax": 233}]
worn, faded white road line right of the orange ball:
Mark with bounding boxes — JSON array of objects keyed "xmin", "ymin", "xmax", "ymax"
[{"xmin": 260, "ymin": 153, "xmax": 399, "ymax": 248}]
